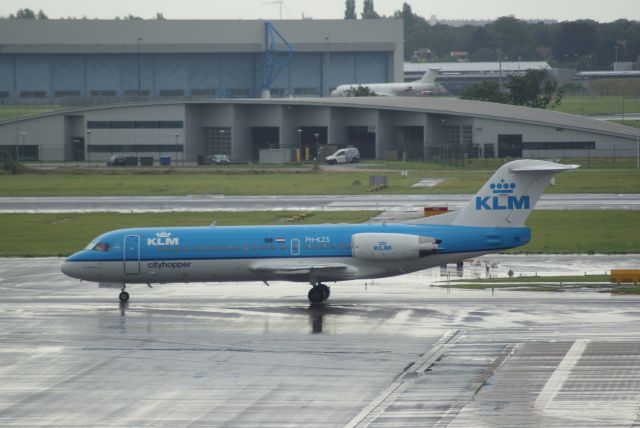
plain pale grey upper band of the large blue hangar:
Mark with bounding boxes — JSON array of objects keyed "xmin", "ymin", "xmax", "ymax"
[{"xmin": 0, "ymin": 19, "xmax": 403, "ymax": 54}]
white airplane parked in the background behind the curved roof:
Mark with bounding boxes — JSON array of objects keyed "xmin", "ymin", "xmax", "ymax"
[{"xmin": 331, "ymin": 68, "xmax": 447, "ymax": 97}]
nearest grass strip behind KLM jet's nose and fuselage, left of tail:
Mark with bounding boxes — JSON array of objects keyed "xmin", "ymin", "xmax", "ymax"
[{"xmin": 0, "ymin": 211, "xmax": 378, "ymax": 257}]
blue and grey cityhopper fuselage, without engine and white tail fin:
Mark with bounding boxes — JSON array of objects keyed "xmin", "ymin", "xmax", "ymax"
[{"xmin": 63, "ymin": 224, "xmax": 530, "ymax": 283}]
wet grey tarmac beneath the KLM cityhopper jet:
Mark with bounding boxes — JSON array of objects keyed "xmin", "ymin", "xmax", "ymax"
[{"xmin": 0, "ymin": 255, "xmax": 640, "ymax": 427}]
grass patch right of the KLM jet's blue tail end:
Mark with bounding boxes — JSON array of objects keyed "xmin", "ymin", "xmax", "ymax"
[{"xmin": 509, "ymin": 210, "xmax": 640, "ymax": 254}]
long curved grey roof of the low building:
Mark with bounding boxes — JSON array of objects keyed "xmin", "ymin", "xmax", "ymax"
[{"xmin": 0, "ymin": 97, "xmax": 640, "ymax": 140}]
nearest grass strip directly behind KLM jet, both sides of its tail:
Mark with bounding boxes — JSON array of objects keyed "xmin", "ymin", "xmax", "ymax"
[{"xmin": 0, "ymin": 211, "xmax": 640, "ymax": 256}]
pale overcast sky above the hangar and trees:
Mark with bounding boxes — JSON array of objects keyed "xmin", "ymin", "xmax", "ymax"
[{"xmin": 0, "ymin": 0, "xmax": 640, "ymax": 22}]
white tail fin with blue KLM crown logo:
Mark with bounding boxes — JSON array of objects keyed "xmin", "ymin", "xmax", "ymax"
[{"xmin": 421, "ymin": 159, "xmax": 578, "ymax": 227}]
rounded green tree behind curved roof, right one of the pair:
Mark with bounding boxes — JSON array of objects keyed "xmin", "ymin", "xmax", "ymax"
[{"xmin": 505, "ymin": 70, "xmax": 562, "ymax": 109}]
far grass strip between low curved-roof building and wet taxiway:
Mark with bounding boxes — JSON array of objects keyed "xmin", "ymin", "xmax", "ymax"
[{"xmin": 0, "ymin": 167, "xmax": 640, "ymax": 196}]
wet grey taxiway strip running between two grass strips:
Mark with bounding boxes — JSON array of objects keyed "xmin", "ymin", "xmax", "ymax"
[{"xmin": 0, "ymin": 193, "xmax": 640, "ymax": 213}]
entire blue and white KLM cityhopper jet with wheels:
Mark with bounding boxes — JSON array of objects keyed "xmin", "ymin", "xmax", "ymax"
[{"xmin": 61, "ymin": 160, "xmax": 577, "ymax": 303}]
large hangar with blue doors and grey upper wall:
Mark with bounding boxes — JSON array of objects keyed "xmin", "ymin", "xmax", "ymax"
[{"xmin": 0, "ymin": 19, "xmax": 404, "ymax": 105}]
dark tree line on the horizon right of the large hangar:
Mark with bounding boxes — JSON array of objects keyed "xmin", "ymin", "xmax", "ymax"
[{"xmin": 345, "ymin": 0, "xmax": 640, "ymax": 69}]
